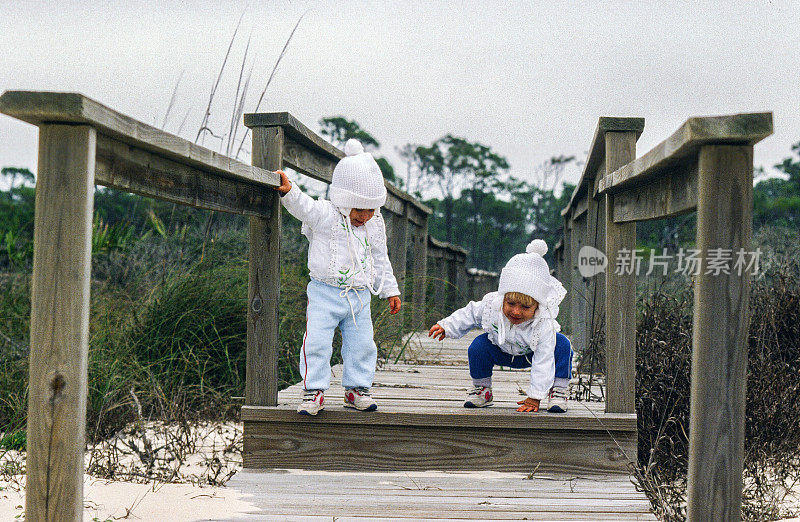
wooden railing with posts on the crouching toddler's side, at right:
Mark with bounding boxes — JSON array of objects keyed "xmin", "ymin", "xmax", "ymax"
[{"xmin": 554, "ymin": 113, "xmax": 772, "ymax": 520}]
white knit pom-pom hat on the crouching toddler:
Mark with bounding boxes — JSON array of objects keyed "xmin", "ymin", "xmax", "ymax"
[{"xmin": 497, "ymin": 239, "xmax": 567, "ymax": 312}]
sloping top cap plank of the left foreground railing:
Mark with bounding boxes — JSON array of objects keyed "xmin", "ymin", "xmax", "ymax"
[{"xmin": 0, "ymin": 91, "xmax": 275, "ymax": 189}]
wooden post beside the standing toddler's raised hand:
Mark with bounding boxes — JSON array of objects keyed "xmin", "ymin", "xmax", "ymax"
[{"xmin": 245, "ymin": 127, "xmax": 284, "ymax": 406}]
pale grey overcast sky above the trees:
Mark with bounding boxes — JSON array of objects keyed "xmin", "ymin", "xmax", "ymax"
[{"xmin": 0, "ymin": 0, "xmax": 800, "ymax": 191}]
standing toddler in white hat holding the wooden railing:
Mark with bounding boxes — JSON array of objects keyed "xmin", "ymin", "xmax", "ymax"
[{"xmin": 276, "ymin": 139, "xmax": 401, "ymax": 415}]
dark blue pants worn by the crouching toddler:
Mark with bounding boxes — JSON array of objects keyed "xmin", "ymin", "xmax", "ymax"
[{"xmin": 467, "ymin": 333, "xmax": 572, "ymax": 387}]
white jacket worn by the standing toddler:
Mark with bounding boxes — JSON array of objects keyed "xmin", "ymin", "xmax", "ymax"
[{"xmin": 281, "ymin": 183, "xmax": 400, "ymax": 299}]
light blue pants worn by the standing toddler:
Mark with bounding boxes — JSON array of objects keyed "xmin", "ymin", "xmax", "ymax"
[{"xmin": 300, "ymin": 280, "xmax": 378, "ymax": 390}]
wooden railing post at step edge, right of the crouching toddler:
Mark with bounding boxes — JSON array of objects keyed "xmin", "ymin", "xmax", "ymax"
[{"xmin": 604, "ymin": 132, "xmax": 638, "ymax": 413}]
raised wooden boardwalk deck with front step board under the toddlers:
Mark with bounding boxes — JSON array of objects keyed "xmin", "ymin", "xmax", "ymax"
[{"xmin": 242, "ymin": 334, "xmax": 636, "ymax": 474}]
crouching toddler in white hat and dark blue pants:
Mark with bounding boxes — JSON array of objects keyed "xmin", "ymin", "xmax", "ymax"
[{"xmin": 428, "ymin": 239, "xmax": 572, "ymax": 413}]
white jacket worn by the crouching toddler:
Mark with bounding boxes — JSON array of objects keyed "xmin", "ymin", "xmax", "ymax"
[{"xmin": 439, "ymin": 292, "xmax": 561, "ymax": 400}]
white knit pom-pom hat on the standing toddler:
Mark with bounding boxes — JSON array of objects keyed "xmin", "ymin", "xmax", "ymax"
[{"xmin": 329, "ymin": 138, "xmax": 386, "ymax": 209}]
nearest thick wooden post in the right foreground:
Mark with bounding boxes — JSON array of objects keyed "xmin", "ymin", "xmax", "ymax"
[{"xmin": 687, "ymin": 145, "xmax": 753, "ymax": 520}]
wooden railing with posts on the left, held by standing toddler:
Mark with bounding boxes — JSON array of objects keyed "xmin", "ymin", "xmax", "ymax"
[{"xmin": 0, "ymin": 91, "xmax": 488, "ymax": 521}]
